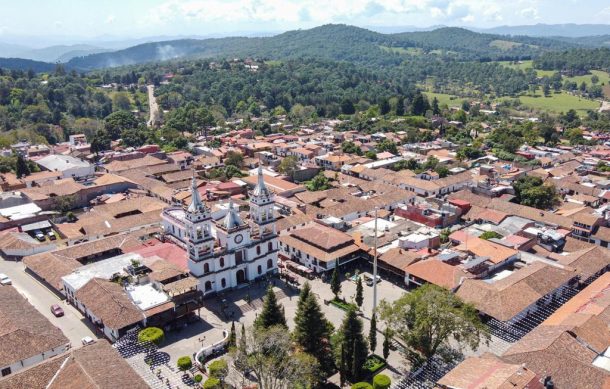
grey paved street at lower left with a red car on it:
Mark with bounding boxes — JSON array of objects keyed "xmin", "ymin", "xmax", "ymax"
[{"xmin": 0, "ymin": 259, "xmax": 97, "ymax": 348}]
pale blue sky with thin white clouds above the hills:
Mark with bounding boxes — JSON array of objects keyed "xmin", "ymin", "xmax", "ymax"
[{"xmin": 0, "ymin": 0, "xmax": 610, "ymax": 39}]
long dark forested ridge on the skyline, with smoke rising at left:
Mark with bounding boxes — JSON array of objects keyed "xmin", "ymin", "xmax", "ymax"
[{"xmin": 61, "ymin": 24, "xmax": 580, "ymax": 70}]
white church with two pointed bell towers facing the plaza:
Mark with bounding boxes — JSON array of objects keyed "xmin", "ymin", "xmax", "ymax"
[{"xmin": 162, "ymin": 168, "xmax": 279, "ymax": 294}]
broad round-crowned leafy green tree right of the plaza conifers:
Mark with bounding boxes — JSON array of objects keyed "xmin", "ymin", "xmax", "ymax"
[{"xmin": 380, "ymin": 284, "xmax": 489, "ymax": 360}]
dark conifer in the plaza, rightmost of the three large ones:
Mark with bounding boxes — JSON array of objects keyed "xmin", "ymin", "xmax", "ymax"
[{"xmin": 334, "ymin": 308, "xmax": 368, "ymax": 382}]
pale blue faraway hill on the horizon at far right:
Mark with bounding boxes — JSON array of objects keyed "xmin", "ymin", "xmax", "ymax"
[{"xmin": 473, "ymin": 23, "xmax": 610, "ymax": 38}]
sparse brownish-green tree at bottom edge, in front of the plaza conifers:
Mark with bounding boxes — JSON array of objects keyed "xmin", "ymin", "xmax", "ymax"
[{"xmin": 242, "ymin": 326, "xmax": 319, "ymax": 389}]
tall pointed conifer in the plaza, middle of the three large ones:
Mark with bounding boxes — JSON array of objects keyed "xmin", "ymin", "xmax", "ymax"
[{"xmin": 293, "ymin": 282, "xmax": 334, "ymax": 373}]
